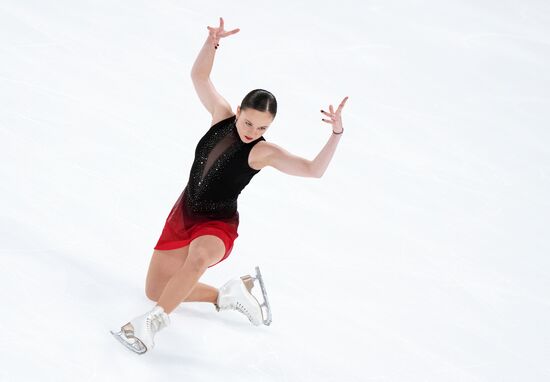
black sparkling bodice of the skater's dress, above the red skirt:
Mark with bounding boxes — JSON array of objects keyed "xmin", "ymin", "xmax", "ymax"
[{"xmin": 184, "ymin": 115, "xmax": 265, "ymax": 219}]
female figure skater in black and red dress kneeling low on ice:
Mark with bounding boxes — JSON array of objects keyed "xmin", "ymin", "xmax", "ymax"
[{"xmin": 111, "ymin": 17, "xmax": 348, "ymax": 354}]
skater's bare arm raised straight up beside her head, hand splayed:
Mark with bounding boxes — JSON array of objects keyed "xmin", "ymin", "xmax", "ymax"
[{"xmin": 191, "ymin": 17, "xmax": 240, "ymax": 124}]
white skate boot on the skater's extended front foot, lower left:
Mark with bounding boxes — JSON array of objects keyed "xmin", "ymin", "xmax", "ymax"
[{"xmin": 111, "ymin": 305, "xmax": 170, "ymax": 354}]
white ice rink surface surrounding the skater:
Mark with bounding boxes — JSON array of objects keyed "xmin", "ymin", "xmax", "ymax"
[{"xmin": 0, "ymin": 0, "xmax": 550, "ymax": 382}]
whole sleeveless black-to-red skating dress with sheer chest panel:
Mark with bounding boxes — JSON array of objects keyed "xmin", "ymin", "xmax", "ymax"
[{"xmin": 155, "ymin": 115, "xmax": 265, "ymax": 267}]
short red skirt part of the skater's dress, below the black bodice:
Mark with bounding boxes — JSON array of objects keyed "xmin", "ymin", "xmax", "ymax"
[{"xmin": 154, "ymin": 191, "xmax": 239, "ymax": 268}]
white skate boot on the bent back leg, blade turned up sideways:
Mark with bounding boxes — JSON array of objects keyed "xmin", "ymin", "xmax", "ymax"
[{"xmin": 216, "ymin": 267, "xmax": 271, "ymax": 326}]
